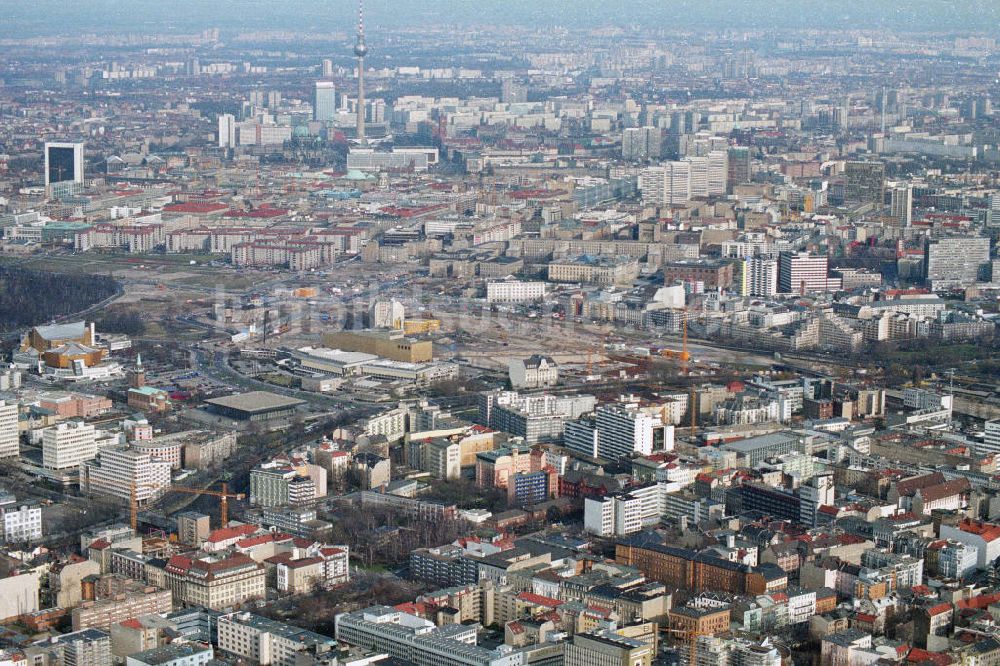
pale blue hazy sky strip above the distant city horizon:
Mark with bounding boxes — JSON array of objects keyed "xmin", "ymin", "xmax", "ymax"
[{"xmin": 7, "ymin": 0, "xmax": 1000, "ymax": 38}]
